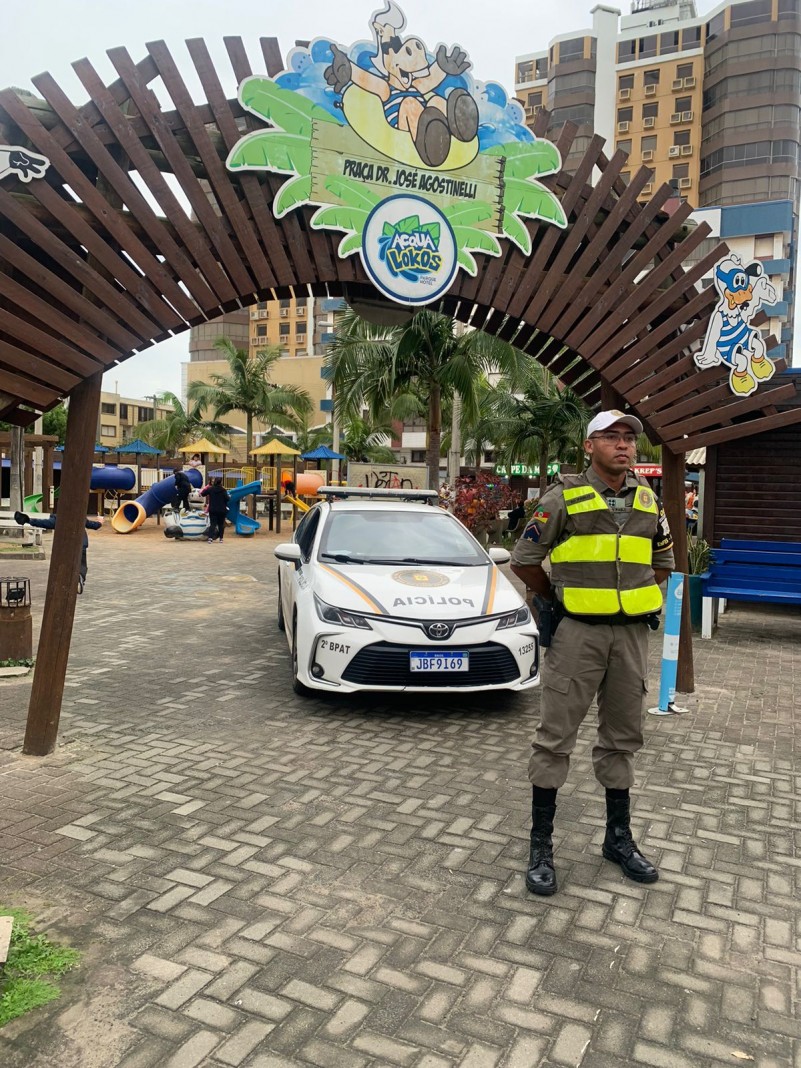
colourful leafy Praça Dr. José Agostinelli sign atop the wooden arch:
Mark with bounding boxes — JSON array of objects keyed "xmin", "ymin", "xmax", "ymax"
[{"xmin": 226, "ymin": 0, "xmax": 567, "ymax": 305}]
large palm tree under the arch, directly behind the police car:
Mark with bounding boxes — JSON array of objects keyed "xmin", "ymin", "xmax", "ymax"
[{"xmin": 327, "ymin": 310, "xmax": 529, "ymax": 486}]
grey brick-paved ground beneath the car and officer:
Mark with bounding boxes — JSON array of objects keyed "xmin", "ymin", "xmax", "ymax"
[{"xmin": 0, "ymin": 527, "xmax": 801, "ymax": 1068}]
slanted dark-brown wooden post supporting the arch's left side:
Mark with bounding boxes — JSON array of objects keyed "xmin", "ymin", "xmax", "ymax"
[{"xmin": 22, "ymin": 371, "xmax": 103, "ymax": 756}]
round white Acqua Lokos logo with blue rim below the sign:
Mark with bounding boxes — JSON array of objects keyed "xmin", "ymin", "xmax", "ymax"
[{"xmin": 360, "ymin": 195, "xmax": 456, "ymax": 304}]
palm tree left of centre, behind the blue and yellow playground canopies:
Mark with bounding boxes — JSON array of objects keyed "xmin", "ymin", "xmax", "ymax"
[{"xmin": 187, "ymin": 337, "xmax": 312, "ymax": 456}]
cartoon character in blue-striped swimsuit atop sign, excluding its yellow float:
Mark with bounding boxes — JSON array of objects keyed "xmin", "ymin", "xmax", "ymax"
[{"xmin": 325, "ymin": 0, "xmax": 478, "ymax": 167}]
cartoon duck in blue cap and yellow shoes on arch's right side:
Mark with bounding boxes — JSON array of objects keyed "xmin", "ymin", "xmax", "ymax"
[{"xmin": 695, "ymin": 255, "xmax": 776, "ymax": 396}]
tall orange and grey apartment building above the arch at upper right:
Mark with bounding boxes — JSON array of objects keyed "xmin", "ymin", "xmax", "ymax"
[{"xmin": 516, "ymin": 0, "xmax": 801, "ymax": 360}]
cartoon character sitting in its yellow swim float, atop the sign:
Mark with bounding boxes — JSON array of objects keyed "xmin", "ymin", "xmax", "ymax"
[{"xmin": 325, "ymin": 0, "xmax": 478, "ymax": 170}]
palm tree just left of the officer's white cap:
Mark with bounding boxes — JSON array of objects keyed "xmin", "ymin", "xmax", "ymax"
[{"xmin": 480, "ymin": 361, "xmax": 590, "ymax": 496}]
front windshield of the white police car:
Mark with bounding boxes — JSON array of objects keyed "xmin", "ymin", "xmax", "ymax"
[{"xmin": 319, "ymin": 508, "xmax": 488, "ymax": 567}]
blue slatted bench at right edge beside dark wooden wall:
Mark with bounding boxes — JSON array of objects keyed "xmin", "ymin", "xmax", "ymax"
[{"xmin": 701, "ymin": 537, "xmax": 801, "ymax": 638}]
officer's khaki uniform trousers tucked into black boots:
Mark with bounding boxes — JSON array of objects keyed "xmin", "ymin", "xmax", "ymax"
[{"xmin": 529, "ymin": 616, "xmax": 648, "ymax": 789}]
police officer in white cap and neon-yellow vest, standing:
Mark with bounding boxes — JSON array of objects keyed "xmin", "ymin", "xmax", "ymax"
[{"xmin": 512, "ymin": 411, "xmax": 674, "ymax": 896}]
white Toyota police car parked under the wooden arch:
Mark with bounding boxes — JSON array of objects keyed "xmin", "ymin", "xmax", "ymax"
[{"xmin": 273, "ymin": 487, "xmax": 539, "ymax": 693}]
